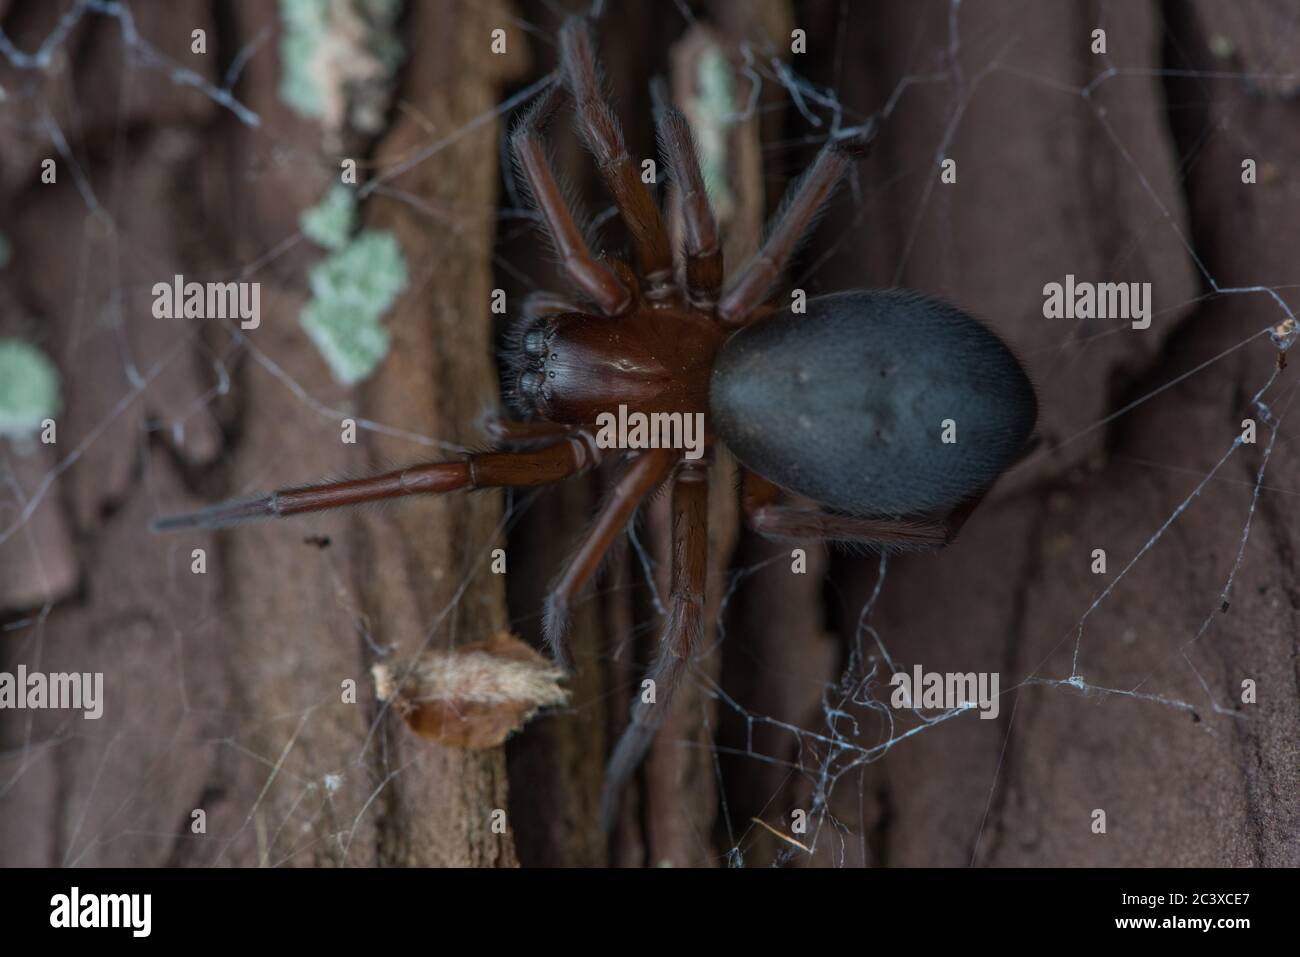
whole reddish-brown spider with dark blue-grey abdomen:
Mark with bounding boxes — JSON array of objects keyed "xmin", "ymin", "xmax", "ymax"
[{"xmin": 155, "ymin": 17, "xmax": 1037, "ymax": 828}]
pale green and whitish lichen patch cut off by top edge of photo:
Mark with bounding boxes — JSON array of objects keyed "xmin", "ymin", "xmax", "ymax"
[{"xmin": 280, "ymin": 0, "xmax": 403, "ymax": 134}]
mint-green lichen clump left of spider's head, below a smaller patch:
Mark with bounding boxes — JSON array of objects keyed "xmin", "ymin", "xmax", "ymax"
[{"xmin": 298, "ymin": 230, "xmax": 407, "ymax": 385}]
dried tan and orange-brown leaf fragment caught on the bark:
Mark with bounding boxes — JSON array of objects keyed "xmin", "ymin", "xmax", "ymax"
[{"xmin": 372, "ymin": 632, "xmax": 568, "ymax": 748}]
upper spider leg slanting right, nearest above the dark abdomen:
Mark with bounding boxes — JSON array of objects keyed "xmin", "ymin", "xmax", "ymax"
[{"xmin": 718, "ymin": 127, "xmax": 874, "ymax": 326}]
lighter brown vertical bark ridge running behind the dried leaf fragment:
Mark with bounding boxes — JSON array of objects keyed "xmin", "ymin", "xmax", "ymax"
[{"xmin": 358, "ymin": 3, "xmax": 521, "ymax": 866}]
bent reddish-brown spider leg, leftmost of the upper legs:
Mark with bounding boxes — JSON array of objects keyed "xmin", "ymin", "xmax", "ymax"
[{"xmin": 510, "ymin": 87, "xmax": 633, "ymax": 316}]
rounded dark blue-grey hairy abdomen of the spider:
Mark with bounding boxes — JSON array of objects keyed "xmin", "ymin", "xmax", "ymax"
[{"xmin": 709, "ymin": 290, "xmax": 1037, "ymax": 515}]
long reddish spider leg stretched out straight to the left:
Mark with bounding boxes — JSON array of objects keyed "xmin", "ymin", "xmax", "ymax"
[{"xmin": 153, "ymin": 432, "xmax": 599, "ymax": 532}]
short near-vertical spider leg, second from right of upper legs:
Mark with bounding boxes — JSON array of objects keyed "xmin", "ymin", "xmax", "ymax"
[{"xmin": 657, "ymin": 107, "xmax": 723, "ymax": 311}]
